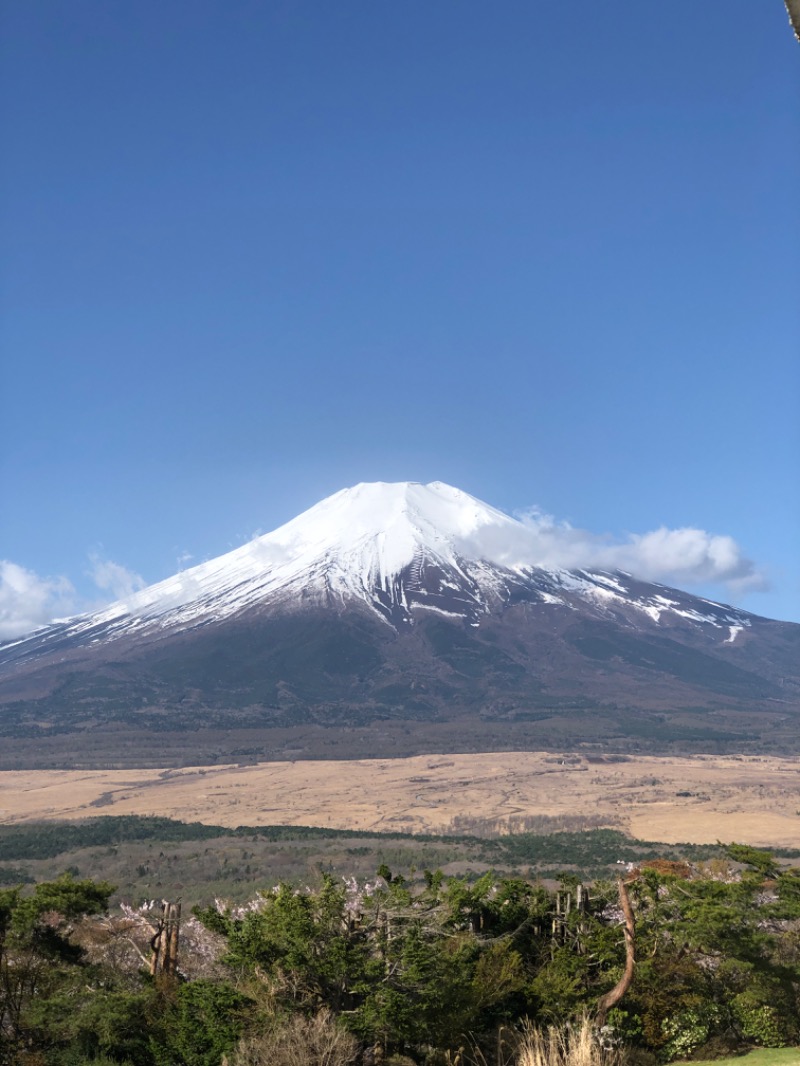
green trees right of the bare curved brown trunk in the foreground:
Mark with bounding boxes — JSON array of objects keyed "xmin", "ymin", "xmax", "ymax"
[{"xmin": 629, "ymin": 845, "xmax": 800, "ymax": 1059}]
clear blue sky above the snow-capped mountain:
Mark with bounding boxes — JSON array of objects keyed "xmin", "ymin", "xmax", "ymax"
[{"xmin": 0, "ymin": 0, "xmax": 800, "ymax": 633}]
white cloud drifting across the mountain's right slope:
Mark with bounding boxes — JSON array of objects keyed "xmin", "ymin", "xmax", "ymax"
[{"xmin": 456, "ymin": 507, "xmax": 767, "ymax": 595}]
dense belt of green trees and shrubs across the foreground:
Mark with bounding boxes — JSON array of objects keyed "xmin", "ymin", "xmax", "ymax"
[{"xmin": 0, "ymin": 845, "xmax": 800, "ymax": 1066}]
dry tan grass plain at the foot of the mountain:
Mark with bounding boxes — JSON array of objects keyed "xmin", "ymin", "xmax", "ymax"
[{"xmin": 0, "ymin": 753, "xmax": 800, "ymax": 847}]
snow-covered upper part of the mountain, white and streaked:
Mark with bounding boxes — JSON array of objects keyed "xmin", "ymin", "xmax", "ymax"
[{"xmin": 1, "ymin": 482, "xmax": 750, "ymax": 655}]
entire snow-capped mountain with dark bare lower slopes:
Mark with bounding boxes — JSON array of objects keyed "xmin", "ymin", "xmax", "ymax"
[{"xmin": 0, "ymin": 482, "xmax": 800, "ymax": 765}]
